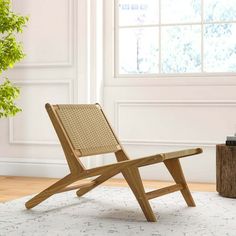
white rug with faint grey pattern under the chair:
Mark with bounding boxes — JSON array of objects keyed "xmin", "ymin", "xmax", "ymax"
[{"xmin": 0, "ymin": 187, "xmax": 236, "ymax": 236}]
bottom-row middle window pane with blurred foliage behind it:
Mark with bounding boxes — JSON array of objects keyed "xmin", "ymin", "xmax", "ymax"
[{"xmin": 161, "ymin": 25, "xmax": 201, "ymax": 73}]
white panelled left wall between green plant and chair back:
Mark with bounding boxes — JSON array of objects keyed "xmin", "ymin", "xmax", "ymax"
[{"xmin": 0, "ymin": 0, "xmax": 88, "ymax": 177}]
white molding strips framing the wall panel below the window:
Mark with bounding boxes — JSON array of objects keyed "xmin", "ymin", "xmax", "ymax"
[{"xmin": 114, "ymin": 100, "xmax": 236, "ymax": 147}]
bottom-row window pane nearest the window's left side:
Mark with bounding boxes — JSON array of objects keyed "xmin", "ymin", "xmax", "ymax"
[{"xmin": 119, "ymin": 27, "xmax": 159, "ymax": 74}]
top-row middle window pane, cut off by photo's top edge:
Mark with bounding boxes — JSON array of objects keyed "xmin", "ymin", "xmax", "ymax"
[{"xmin": 161, "ymin": 0, "xmax": 201, "ymax": 24}]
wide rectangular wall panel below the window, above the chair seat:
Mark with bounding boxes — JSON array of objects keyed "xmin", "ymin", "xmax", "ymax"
[{"xmin": 116, "ymin": 101, "xmax": 236, "ymax": 145}]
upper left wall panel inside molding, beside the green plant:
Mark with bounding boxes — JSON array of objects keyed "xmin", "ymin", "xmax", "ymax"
[{"xmin": 13, "ymin": 0, "xmax": 73, "ymax": 66}]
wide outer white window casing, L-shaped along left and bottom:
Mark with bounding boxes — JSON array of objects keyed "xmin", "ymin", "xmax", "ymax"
[{"xmin": 103, "ymin": 0, "xmax": 236, "ymax": 89}]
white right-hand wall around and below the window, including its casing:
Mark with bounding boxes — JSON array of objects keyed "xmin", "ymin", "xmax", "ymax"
[{"xmin": 104, "ymin": 0, "xmax": 236, "ymax": 182}]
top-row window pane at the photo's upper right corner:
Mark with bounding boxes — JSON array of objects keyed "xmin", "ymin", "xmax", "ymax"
[{"xmin": 203, "ymin": 0, "xmax": 236, "ymax": 22}]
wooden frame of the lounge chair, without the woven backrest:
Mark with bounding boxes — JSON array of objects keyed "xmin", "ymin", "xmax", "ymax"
[{"xmin": 25, "ymin": 104, "xmax": 202, "ymax": 222}]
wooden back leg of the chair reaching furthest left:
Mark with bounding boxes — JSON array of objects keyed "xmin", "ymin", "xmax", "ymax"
[{"xmin": 25, "ymin": 175, "xmax": 77, "ymax": 209}]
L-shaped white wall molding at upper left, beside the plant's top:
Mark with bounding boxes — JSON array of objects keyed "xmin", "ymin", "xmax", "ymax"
[{"xmin": 15, "ymin": 0, "xmax": 74, "ymax": 68}]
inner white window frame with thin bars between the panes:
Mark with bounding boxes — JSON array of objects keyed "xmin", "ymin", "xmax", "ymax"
[{"xmin": 109, "ymin": 0, "xmax": 236, "ymax": 83}]
